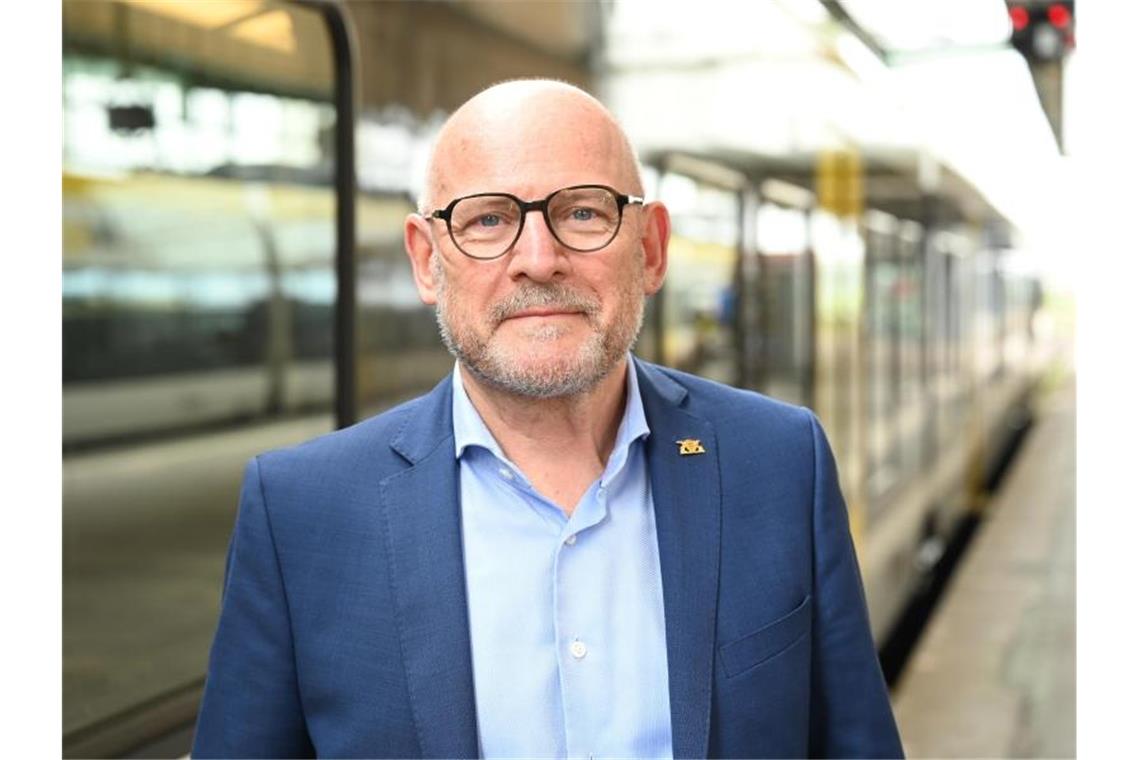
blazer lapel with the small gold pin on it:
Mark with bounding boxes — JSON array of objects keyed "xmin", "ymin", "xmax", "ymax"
[{"xmin": 636, "ymin": 361, "xmax": 720, "ymax": 758}]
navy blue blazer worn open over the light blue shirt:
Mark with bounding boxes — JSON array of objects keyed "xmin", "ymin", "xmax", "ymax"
[{"xmin": 194, "ymin": 361, "xmax": 902, "ymax": 758}]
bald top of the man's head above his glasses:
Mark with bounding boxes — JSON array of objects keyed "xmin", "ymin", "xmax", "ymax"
[{"xmin": 420, "ymin": 80, "xmax": 643, "ymax": 212}]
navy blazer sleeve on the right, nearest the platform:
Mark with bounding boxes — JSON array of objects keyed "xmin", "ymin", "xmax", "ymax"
[{"xmin": 809, "ymin": 414, "xmax": 903, "ymax": 758}]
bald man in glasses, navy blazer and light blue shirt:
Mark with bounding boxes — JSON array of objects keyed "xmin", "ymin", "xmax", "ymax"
[{"xmin": 194, "ymin": 81, "xmax": 901, "ymax": 758}]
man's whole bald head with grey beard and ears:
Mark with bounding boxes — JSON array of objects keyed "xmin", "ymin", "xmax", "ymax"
[{"xmin": 405, "ymin": 80, "xmax": 669, "ymax": 398}]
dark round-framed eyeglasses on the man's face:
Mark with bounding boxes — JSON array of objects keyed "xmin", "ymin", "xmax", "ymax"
[{"xmin": 428, "ymin": 185, "xmax": 645, "ymax": 260}]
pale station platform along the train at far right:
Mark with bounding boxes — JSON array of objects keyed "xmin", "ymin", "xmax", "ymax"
[{"xmin": 891, "ymin": 375, "xmax": 1076, "ymax": 758}]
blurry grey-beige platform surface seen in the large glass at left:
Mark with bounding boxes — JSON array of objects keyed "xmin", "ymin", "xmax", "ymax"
[{"xmin": 63, "ymin": 417, "xmax": 332, "ymax": 735}]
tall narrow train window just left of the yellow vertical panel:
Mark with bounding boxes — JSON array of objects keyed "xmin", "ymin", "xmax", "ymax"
[{"xmin": 756, "ymin": 203, "xmax": 815, "ymax": 404}]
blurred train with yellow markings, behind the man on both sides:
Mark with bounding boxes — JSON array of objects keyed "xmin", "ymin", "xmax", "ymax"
[{"xmin": 62, "ymin": 0, "xmax": 1052, "ymax": 757}]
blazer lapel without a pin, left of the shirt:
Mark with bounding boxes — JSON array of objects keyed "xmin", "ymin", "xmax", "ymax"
[{"xmin": 381, "ymin": 375, "xmax": 479, "ymax": 758}]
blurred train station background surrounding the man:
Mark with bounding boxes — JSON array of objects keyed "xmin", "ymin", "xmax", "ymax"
[{"xmin": 62, "ymin": 0, "xmax": 1083, "ymax": 757}]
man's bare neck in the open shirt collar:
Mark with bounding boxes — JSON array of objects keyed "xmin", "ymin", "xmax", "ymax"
[{"xmin": 459, "ymin": 357, "xmax": 629, "ymax": 514}]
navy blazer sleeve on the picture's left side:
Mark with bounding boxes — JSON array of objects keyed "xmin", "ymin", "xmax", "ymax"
[{"xmin": 192, "ymin": 459, "xmax": 315, "ymax": 758}]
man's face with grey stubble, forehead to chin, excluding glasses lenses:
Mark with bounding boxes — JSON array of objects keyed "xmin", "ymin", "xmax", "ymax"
[{"xmin": 409, "ymin": 89, "xmax": 667, "ymax": 398}]
